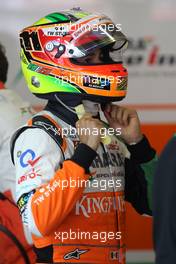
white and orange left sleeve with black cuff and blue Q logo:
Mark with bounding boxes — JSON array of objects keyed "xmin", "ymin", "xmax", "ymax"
[{"xmin": 14, "ymin": 128, "xmax": 97, "ymax": 237}]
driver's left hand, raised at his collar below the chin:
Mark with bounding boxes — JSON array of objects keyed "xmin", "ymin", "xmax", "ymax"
[{"xmin": 76, "ymin": 113, "xmax": 103, "ymax": 151}]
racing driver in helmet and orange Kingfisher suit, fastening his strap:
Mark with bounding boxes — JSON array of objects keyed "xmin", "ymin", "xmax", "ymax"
[{"xmin": 11, "ymin": 8, "xmax": 156, "ymax": 264}]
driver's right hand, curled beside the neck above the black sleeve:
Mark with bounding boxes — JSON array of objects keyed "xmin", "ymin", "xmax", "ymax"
[{"xmin": 104, "ymin": 104, "xmax": 143, "ymax": 144}]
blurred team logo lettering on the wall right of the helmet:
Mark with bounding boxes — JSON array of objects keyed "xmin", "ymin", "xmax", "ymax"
[{"xmin": 124, "ymin": 36, "xmax": 176, "ymax": 67}]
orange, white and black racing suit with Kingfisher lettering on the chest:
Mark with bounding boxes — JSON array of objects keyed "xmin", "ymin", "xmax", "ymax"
[{"xmin": 12, "ymin": 103, "xmax": 155, "ymax": 264}]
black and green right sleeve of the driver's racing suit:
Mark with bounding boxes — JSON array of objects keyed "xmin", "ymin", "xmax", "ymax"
[{"xmin": 125, "ymin": 136, "xmax": 157, "ymax": 215}]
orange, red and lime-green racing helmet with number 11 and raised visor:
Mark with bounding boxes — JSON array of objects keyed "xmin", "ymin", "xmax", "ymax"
[{"xmin": 20, "ymin": 8, "xmax": 128, "ymax": 102}]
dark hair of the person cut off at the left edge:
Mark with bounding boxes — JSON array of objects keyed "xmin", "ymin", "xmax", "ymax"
[{"xmin": 0, "ymin": 44, "xmax": 8, "ymax": 83}]
